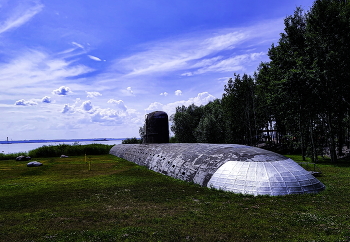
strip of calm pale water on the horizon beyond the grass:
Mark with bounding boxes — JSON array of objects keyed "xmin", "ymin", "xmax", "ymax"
[{"xmin": 0, "ymin": 140, "xmax": 122, "ymax": 154}]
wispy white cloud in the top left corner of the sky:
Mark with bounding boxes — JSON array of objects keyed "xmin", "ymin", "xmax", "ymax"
[{"xmin": 0, "ymin": 1, "xmax": 44, "ymax": 34}]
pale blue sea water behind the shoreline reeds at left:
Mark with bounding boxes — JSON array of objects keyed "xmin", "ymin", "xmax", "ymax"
[{"xmin": 0, "ymin": 139, "xmax": 123, "ymax": 154}]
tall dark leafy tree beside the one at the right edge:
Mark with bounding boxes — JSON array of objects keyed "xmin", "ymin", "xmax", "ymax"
[{"xmin": 257, "ymin": 8, "xmax": 313, "ymax": 159}]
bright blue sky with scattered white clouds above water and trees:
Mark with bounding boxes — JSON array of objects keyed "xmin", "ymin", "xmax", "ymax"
[{"xmin": 0, "ymin": 0, "xmax": 313, "ymax": 140}]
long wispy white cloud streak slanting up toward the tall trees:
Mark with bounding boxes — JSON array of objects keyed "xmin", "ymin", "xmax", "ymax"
[{"xmin": 115, "ymin": 19, "xmax": 281, "ymax": 76}]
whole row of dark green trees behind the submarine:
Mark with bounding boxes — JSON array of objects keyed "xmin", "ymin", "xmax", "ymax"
[{"xmin": 171, "ymin": 0, "xmax": 350, "ymax": 161}]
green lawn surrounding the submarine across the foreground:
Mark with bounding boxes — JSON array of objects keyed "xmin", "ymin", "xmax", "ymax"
[{"xmin": 0, "ymin": 155, "xmax": 350, "ymax": 241}]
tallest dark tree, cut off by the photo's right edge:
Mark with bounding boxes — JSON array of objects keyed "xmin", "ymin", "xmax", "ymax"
[{"xmin": 306, "ymin": 0, "xmax": 350, "ymax": 161}]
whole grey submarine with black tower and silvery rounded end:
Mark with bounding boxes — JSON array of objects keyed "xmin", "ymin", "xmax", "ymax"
[{"xmin": 110, "ymin": 111, "xmax": 325, "ymax": 196}]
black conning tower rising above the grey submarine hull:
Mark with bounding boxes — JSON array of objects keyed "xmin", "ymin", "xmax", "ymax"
[{"xmin": 143, "ymin": 111, "xmax": 169, "ymax": 144}]
